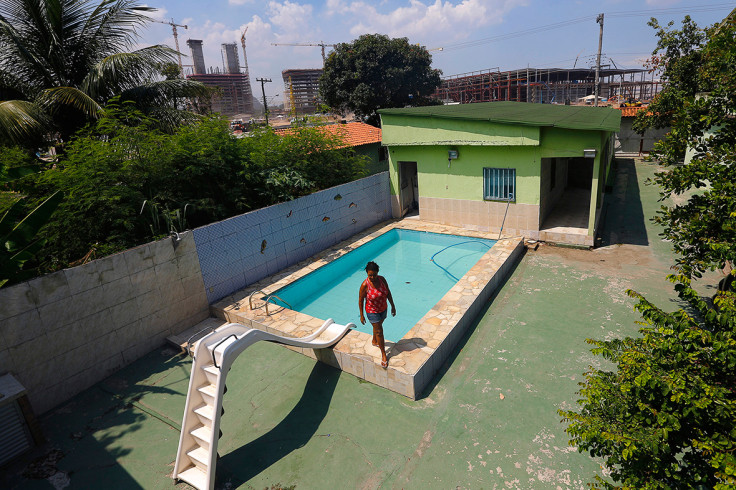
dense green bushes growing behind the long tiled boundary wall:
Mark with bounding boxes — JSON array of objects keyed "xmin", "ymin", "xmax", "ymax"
[{"xmin": 10, "ymin": 101, "xmax": 364, "ymax": 271}]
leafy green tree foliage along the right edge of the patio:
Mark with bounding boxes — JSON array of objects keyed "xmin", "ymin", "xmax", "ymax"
[{"xmin": 559, "ymin": 10, "xmax": 736, "ymax": 489}]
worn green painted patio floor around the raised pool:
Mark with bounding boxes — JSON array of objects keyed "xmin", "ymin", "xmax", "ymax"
[{"xmin": 0, "ymin": 160, "xmax": 696, "ymax": 489}]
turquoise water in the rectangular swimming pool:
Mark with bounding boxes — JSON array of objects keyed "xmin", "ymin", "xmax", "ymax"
[{"xmin": 275, "ymin": 229, "xmax": 496, "ymax": 342}]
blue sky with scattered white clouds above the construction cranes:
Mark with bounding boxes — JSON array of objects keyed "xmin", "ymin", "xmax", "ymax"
[{"xmin": 139, "ymin": 0, "xmax": 736, "ymax": 104}]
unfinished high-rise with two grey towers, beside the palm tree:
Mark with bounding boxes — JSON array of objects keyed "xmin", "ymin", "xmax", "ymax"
[{"xmin": 187, "ymin": 39, "xmax": 253, "ymax": 116}]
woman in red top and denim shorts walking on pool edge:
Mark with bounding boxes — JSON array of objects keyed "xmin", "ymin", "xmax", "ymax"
[{"xmin": 358, "ymin": 262, "xmax": 396, "ymax": 369}]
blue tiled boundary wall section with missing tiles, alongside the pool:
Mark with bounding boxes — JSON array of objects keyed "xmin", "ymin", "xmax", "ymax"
[{"xmin": 194, "ymin": 172, "xmax": 391, "ymax": 303}]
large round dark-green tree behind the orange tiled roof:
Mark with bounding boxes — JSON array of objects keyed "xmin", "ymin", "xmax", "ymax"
[{"xmin": 319, "ymin": 34, "xmax": 442, "ymax": 125}]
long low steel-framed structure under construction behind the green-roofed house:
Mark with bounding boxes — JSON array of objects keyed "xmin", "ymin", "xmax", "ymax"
[{"xmin": 434, "ymin": 68, "xmax": 661, "ymax": 104}]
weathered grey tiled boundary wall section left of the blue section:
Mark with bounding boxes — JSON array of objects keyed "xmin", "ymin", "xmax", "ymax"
[{"xmin": 0, "ymin": 232, "xmax": 209, "ymax": 413}]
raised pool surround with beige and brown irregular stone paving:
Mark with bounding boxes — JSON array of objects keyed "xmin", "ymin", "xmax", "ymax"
[{"xmin": 211, "ymin": 220, "xmax": 523, "ymax": 399}]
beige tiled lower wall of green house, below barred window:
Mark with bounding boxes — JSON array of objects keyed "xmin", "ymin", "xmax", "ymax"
[{"xmin": 419, "ymin": 197, "xmax": 539, "ymax": 239}]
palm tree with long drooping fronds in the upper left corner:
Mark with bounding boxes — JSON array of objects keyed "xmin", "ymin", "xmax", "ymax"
[{"xmin": 0, "ymin": 0, "xmax": 204, "ymax": 144}]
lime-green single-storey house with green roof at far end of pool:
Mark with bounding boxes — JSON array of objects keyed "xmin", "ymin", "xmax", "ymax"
[{"xmin": 379, "ymin": 102, "xmax": 621, "ymax": 246}]
